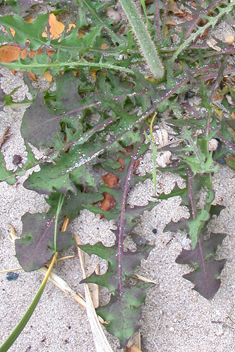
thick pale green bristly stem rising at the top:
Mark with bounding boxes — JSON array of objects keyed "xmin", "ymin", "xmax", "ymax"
[{"xmin": 119, "ymin": 0, "xmax": 164, "ymax": 79}]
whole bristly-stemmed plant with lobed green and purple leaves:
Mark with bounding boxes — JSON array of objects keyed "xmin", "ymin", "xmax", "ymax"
[{"xmin": 0, "ymin": 0, "xmax": 235, "ymax": 347}]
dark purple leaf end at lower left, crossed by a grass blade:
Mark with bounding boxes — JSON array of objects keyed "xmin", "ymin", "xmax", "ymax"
[{"xmin": 15, "ymin": 213, "xmax": 74, "ymax": 271}]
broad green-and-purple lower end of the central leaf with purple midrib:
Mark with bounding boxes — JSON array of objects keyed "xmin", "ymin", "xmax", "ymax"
[{"xmin": 80, "ymin": 242, "xmax": 153, "ymax": 347}]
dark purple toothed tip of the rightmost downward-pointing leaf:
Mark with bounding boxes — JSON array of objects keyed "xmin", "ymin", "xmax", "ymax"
[{"xmin": 176, "ymin": 231, "xmax": 226, "ymax": 299}]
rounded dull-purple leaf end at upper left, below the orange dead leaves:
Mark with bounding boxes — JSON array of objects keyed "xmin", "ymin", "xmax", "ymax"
[{"xmin": 21, "ymin": 72, "xmax": 81, "ymax": 148}]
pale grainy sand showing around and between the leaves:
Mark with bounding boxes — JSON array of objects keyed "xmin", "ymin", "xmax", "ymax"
[{"xmin": 0, "ymin": 53, "xmax": 235, "ymax": 352}]
